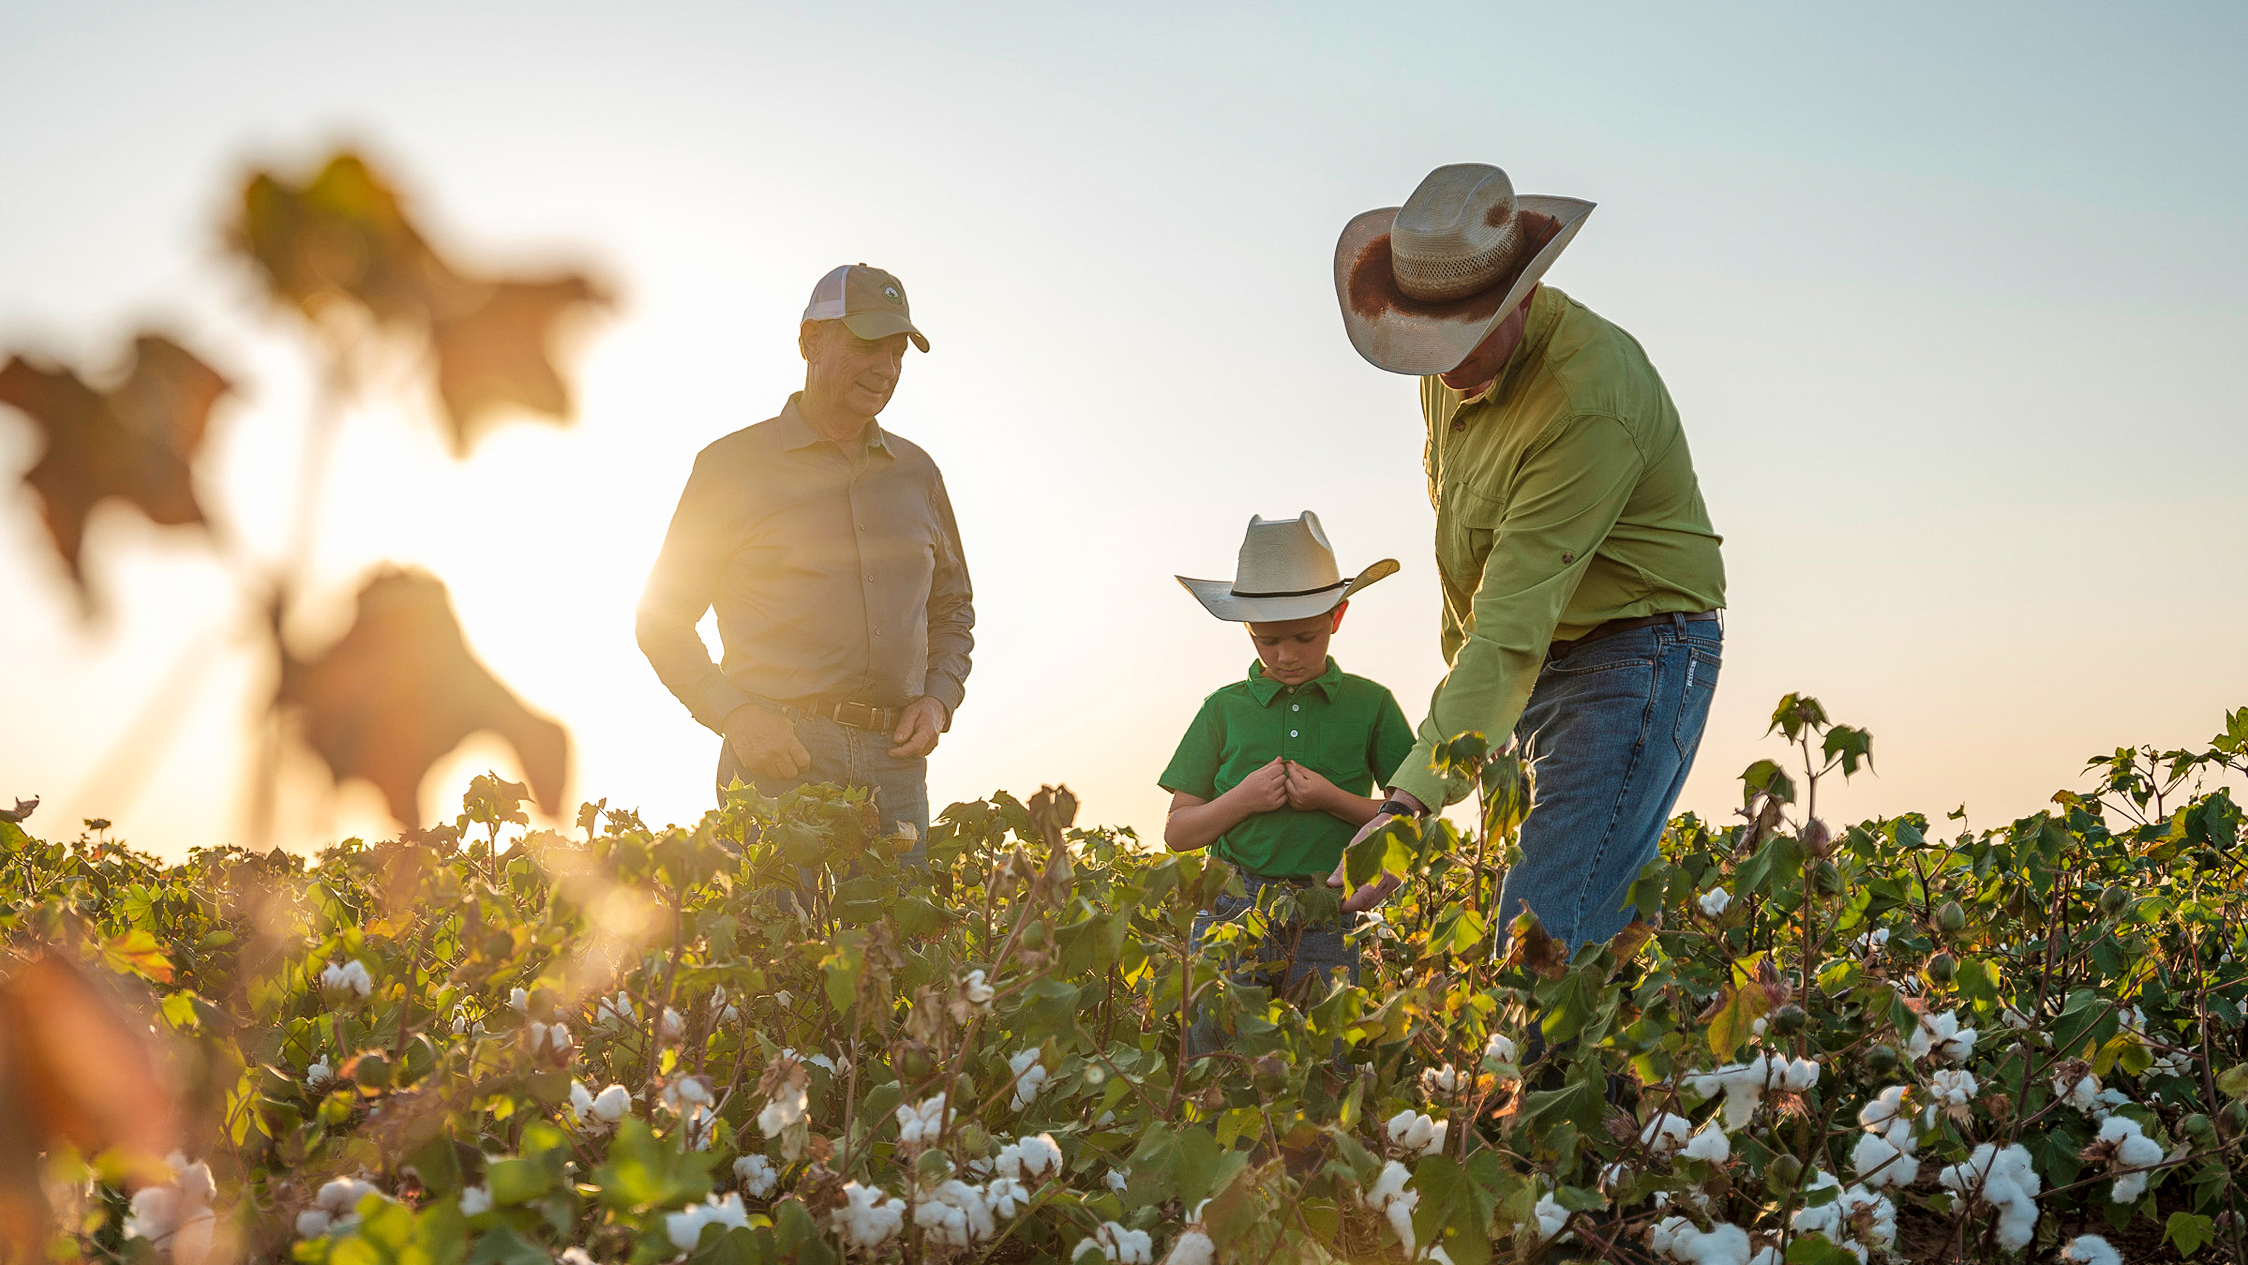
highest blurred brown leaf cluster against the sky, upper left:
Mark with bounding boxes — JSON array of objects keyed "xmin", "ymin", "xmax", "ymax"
[{"xmin": 232, "ymin": 153, "xmax": 607, "ymax": 456}]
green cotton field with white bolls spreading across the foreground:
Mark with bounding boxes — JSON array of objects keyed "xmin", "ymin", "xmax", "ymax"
[{"xmin": 0, "ymin": 697, "xmax": 2248, "ymax": 1265}]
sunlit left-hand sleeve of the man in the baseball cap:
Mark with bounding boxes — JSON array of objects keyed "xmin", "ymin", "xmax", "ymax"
[{"xmin": 634, "ymin": 452, "xmax": 749, "ymax": 732}]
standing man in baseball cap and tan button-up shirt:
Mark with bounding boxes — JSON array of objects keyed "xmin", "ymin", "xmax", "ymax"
[{"xmin": 638, "ymin": 263, "xmax": 976, "ymax": 852}]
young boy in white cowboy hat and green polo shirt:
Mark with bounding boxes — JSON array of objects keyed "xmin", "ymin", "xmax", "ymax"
[{"xmin": 1162, "ymin": 510, "xmax": 1414, "ymax": 1054}]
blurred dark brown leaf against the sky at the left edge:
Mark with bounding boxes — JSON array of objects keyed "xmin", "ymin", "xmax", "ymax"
[{"xmin": 0, "ymin": 333, "xmax": 229, "ymax": 602}]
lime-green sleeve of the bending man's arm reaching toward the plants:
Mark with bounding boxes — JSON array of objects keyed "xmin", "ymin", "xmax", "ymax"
[{"xmin": 1389, "ymin": 416, "xmax": 1646, "ymax": 807}]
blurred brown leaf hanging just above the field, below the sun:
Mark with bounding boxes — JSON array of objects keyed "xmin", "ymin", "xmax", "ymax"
[{"xmin": 279, "ymin": 566, "xmax": 569, "ymax": 827}]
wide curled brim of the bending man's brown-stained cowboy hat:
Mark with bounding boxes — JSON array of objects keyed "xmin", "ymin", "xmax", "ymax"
[{"xmin": 1335, "ymin": 193, "xmax": 1592, "ymax": 375}]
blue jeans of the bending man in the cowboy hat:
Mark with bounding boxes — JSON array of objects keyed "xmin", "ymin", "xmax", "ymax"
[{"xmin": 1499, "ymin": 620, "xmax": 1724, "ymax": 950}]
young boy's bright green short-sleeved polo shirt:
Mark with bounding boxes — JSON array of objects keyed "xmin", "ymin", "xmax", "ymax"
[{"xmin": 1162, "ymin": 658, "xmax": 1414, "ymax": 879}]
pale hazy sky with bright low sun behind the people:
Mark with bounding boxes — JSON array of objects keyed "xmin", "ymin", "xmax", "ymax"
[{"xmin": 0, "ymin": 2, "xmax": 2248, "ymax": 854}]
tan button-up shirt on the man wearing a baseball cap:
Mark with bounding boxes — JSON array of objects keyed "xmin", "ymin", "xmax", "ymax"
[{"xmin": 638, "ymin": 395, "xmax": 976, "ymax": 730}]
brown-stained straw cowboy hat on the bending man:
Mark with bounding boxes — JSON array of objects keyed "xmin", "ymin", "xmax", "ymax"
[{"xmin": 1335, "ymin": 162, "xmax": 1592, "ymax": 373}]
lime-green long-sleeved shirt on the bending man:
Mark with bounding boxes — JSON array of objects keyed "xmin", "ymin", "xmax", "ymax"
[{"xmin": 1389, "ymin": 285, "xmax": 1724, "ymax": 807}]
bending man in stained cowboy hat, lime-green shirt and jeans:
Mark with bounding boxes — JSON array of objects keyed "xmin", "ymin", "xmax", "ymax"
[{"xmin": 1333, "ymin": 164, "xmax": 1724, "ymax": 944}]
